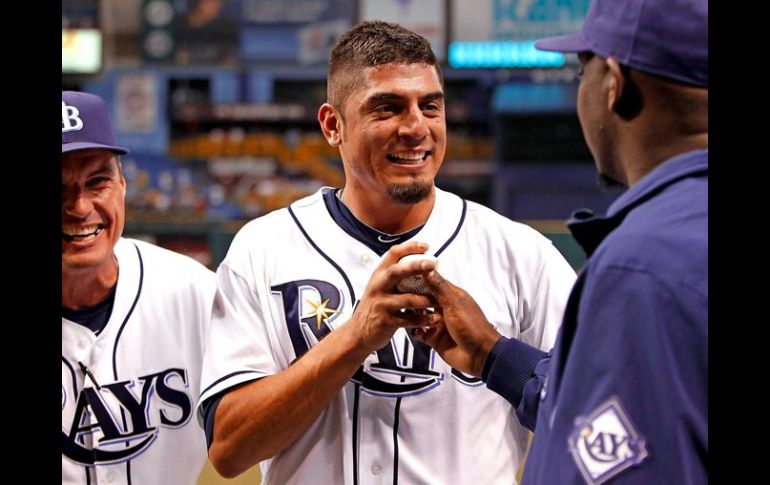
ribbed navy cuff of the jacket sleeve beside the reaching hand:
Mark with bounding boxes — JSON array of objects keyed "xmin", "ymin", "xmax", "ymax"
[{"xmin": 481, "ymin": 337, "xmax": 548, "ymax": 407}]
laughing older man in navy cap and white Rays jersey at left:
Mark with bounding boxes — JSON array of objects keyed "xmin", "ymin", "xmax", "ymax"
[{"xmin": 61, "ymin": 91, "xmax": 216, "ymax": 485}]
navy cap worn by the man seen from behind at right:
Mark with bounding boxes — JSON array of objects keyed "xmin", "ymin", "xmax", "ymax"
[{"xmin": 535, "ymin": 0, "xmax": 709, "ymax": 88}]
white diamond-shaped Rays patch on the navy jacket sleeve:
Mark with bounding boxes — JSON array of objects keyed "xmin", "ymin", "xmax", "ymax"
[{"xmin": 567, "ymin": 397, "xmax": 648, "ymax": 485}]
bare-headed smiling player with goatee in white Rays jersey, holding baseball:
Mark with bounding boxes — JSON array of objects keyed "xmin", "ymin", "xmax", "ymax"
[{"xmin": 200, "ymin": 21, "xmax": 575, "ymax": 484}]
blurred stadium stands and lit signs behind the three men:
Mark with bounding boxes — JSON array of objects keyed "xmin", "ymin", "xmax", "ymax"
[{"xmin": 62, "ymin": 0, "xmax": 618, "ymax": 484}]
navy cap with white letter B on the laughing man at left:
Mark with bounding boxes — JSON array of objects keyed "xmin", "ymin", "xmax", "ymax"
[{"xmin": 61, "ymin": 91, "xmax": 128, "ymax": 154}]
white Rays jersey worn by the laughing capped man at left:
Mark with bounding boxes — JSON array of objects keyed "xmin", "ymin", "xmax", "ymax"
[{"xmin": 62, "ymin": 238, "xmax": 216, "ymax": 485}]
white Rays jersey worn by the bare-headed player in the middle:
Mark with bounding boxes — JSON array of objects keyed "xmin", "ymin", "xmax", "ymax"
[{"xmin": 201, "ymin": 188, "xmax": 575, "ymax": 484}]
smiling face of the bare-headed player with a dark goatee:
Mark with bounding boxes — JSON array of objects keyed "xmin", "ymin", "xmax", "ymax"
[{"xmin": 322, "ymin": 63, "xmax": 446, "ymax": 204}]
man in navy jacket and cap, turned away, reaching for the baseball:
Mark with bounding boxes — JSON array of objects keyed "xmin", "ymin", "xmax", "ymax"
[{"xmin": 418, "ymin": 0, "xmax": 708, "ymax": 484}]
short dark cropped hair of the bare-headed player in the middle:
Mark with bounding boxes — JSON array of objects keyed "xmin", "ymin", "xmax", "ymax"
[{"xmin": 326, "ymin": 20, "xmax": 444, "ymax": 110}]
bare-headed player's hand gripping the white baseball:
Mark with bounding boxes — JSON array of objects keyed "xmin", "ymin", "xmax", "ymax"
[{"xmin": 346, "ymin": 242, "xmax": 439, "ymax": 352}]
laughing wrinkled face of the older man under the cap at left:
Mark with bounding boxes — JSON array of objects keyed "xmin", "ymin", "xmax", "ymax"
[{"xmin": 61, "ymin": 149, "xmax": 126, "ymax": 273}]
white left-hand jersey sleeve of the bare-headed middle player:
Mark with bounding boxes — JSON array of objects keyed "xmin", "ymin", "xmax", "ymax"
[{"xmin": 199, "ymin": 261, "xmax": 279, "ymax": 418}]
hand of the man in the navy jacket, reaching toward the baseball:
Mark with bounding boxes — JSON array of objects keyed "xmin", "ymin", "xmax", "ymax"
[{"xmin": 414, "ymin": 271, "xmax": 501, "ymax": 377}]
